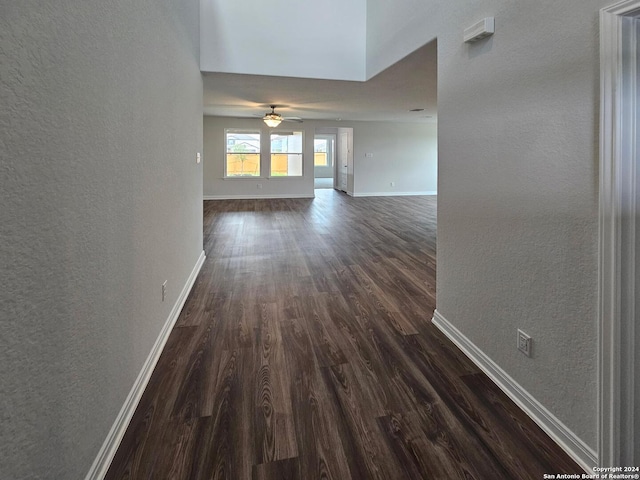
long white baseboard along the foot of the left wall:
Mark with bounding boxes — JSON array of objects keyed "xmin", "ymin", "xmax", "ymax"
[{"xmin": 85, "ymin": 251, "xmax": 205, "ymax": 480}]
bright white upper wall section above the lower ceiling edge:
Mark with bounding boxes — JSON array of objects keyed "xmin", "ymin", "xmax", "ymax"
[{"xmin": 200, "ymin": 0, "xmax": 367, "ymax": 80}]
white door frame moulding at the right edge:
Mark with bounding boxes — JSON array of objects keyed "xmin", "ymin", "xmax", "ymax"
[{"xmin": 598, "ymin": 0, "xmax": 640, "ymax": 466}]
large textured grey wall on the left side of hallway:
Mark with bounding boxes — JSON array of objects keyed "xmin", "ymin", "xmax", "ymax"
[{"xmin": 0, "ymin": 0, "xmax": 202, "ymax": 479}]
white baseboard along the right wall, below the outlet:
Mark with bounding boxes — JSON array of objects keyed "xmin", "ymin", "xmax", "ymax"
[{"xmin": 431, "ymin": 310, "xmax": 598, "ymax": 473}]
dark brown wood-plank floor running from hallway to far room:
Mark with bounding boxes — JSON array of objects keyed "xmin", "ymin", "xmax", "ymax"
[{"xmin": 107, "ymin": 190, "xmax": 583, "ymax": 480}]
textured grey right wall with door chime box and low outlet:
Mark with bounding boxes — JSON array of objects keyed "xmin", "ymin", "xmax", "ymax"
[{"xmin": 367, "ymin": 0, "xmax": 613, "ymax": 449}]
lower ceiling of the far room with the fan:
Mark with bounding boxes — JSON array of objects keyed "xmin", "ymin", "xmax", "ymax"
[{"xmin": 204, "ymin": 42, "xmax": 437, "ymax": 123}]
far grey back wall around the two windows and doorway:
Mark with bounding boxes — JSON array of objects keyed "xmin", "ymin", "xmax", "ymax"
[{"xmin": 204, "ymin": 116, "xmax": 437, "ymax": 198}]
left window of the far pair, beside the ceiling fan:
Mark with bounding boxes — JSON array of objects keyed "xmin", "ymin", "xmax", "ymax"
[{"xmin": 225, "ymin": 130, "xmax": 260, "ymax": 177}]
